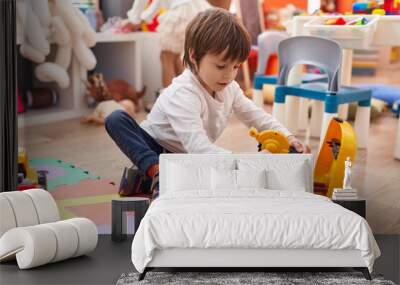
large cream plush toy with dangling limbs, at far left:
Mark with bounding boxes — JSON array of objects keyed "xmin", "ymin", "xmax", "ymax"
[{"xmin": 17, "ymin": 0, "xmax": 96, "ymax": 89}]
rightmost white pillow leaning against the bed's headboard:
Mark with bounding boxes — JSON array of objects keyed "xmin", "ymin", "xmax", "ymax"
[{"xmin": 267, "ymin": 163, "xmax": 309, "ymax": 192}]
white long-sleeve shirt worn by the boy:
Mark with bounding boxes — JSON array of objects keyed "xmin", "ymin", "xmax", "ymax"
[{"xmin": 141, "ymin": 69, "xmax": 291, "ymax": 153}]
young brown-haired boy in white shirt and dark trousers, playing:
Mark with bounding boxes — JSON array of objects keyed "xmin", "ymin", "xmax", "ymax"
[{"xmin": 105, "ymin": 8, "xmax": 306, "ymax": 198}]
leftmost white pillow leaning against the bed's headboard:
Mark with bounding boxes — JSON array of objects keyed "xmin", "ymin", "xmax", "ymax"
[{"xmin": 167, "ymin": 163, "xmax": 211, "ymax": 191}]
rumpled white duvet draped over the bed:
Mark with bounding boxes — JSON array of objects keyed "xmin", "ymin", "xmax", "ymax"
[{"xmin": 132, "ymin": 189, "xmax": 380, "ymax": 272}]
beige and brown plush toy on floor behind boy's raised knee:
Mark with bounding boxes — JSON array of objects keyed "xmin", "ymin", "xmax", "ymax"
[{"xmin": 81, "ymin": 99, "xmax": 135, "ymax": 125}]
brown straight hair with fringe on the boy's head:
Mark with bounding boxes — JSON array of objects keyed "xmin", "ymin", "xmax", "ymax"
[{"xmin": 183, "ymin": 8, "xmax": 251, "ymax": 70}]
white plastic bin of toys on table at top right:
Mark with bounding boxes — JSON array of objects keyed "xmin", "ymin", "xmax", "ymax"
[{"xmin": 304, "ymin": 15, "xmax": 378, "ymax": 49}]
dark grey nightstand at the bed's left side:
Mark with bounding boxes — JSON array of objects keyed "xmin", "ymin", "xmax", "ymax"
[{"xmin": 111, "ymin": 197, "xmax": 150, "ymax": 241}]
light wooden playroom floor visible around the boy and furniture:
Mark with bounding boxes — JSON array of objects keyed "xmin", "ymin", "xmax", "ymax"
[{"xmin": 19, "ymin": 68, "xmax": 400, "ymax": 234}]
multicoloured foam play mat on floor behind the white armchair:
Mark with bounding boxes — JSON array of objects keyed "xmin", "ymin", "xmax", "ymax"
[{"xmin": 29, "ymin": 158, "xmax": 118, "ymax": 234}]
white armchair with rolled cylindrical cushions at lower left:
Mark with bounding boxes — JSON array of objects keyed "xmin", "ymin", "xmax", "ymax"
[{"xmin": 0, "ymin": 189, "xmax": 98, "ymax": 269}]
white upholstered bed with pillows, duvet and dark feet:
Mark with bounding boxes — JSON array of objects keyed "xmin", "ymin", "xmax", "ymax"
[{"xmin": 132, "ymin": 154, "xmax": 380, "ymax": 279}]
